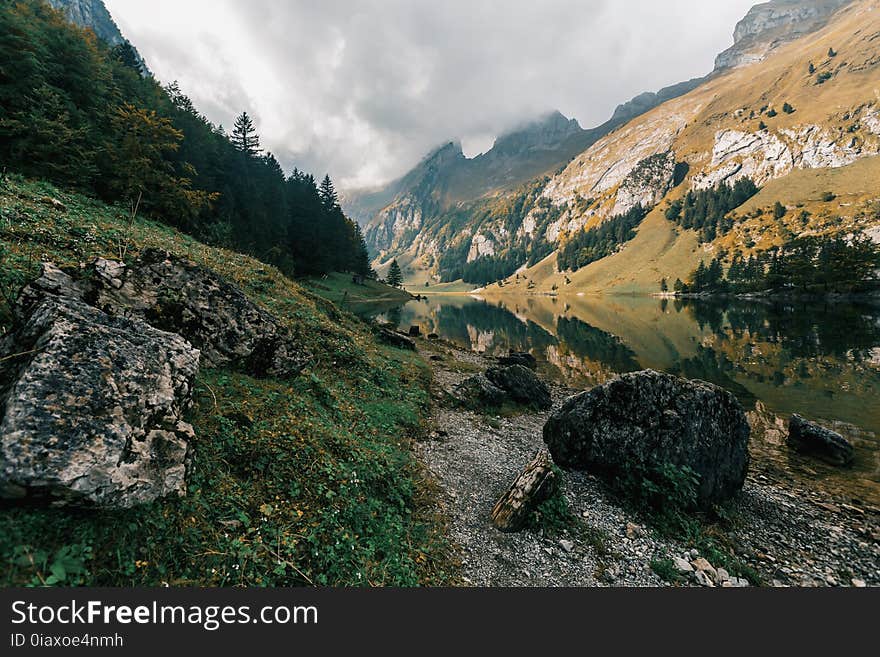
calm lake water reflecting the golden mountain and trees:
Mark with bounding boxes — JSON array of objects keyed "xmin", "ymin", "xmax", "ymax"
[{"xmin": 358, "ymin": 295, "xmax": 880, "ymax": 501}]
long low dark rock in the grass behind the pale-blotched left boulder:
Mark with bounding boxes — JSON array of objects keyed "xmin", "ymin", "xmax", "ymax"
[{"xmin": 19, "ymin": 249, "xmax": 309, "ymax": 377}]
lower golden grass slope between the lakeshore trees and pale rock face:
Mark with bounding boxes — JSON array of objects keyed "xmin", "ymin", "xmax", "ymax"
[{"xmin": 485, "ymin": 157, "xmax": 880, "ymax": 296}]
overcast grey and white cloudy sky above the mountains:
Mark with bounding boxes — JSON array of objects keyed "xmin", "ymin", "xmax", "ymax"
[{"xmin": 105, "ymin": 0, "xmax": 755, "ymax": 188}]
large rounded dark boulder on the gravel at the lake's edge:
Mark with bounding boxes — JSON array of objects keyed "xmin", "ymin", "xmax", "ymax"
[{"xmin": 544, "ymin": 370, "xmax": 749, "ymax": 506}]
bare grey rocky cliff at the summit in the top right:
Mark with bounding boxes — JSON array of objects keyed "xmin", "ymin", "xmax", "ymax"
[{"xmin": 715, "ymin": 0, "xmax": 852, "ymax": 71}]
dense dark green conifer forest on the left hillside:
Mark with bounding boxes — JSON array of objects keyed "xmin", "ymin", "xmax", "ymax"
[{"xmin": 0, "ymin": 0, "xmax": 373, "ymax": 276}]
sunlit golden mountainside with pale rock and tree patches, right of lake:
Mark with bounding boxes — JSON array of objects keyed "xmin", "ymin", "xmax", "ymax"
[{"xmin": 482, "ymin": 0, "xmax": 880, "ymax": 293}]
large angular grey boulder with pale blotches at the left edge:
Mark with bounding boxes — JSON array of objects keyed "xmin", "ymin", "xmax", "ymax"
[{"xmin": 0, "ymin": 298, "xmax": 199, "ymax": 507}]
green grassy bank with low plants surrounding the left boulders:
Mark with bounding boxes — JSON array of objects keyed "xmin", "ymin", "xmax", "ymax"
[{"xmin": 0, "ymin": 178, "xmax": 454, "ymax": 586}]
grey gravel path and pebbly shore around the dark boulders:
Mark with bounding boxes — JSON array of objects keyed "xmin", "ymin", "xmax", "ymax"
[{"xmin": 418, "ymin": 340, "xmax": 880, "ymax": 586}]
